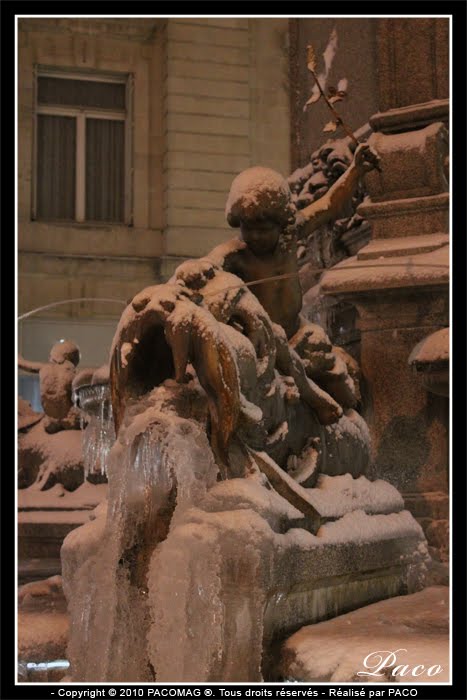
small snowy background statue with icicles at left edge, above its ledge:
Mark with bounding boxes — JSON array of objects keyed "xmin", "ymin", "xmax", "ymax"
[{"xmin": 18, "ymin": 340, "xmax": 111, "ymax": 491}]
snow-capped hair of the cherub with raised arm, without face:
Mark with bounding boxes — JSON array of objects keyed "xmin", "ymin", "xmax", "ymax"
[{"xmin": 225, "ymin": 165, "xmax": 297, "ymax": 228}]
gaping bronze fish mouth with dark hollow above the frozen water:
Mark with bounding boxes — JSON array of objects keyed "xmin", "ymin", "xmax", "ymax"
[{"xmin": 110, "ymin": 285, "xmax": 240, "ymax": 463}]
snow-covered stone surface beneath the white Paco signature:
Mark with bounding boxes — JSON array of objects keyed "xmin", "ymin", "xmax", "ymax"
[{"xmin": 281, "ymin": 586, "xmax": 449, "ymax": 684}]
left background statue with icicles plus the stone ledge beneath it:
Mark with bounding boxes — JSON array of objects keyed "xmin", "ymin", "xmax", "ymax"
[{"xmin": 17, "ymin": 340, "xmax": 113, "ymax": 584}]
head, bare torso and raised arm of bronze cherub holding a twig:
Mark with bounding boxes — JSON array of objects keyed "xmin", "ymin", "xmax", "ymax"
[{"xmin": 209, "ymin": 144, "xmax": 379, "ymax": 339}]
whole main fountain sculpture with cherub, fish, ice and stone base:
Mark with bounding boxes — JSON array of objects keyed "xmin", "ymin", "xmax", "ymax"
[{"xmin": 54, "ymin": 145, "xmax": 428, "ymax": 682}]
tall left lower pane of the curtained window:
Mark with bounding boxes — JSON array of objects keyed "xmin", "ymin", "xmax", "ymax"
[{"xmin": 36, "ymin": 114, "xmax": 76, "ymax": 219}]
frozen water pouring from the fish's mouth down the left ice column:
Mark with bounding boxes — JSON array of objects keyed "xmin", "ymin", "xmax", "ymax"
[{"xmin": 62, "ymin": 409, "xmax": 217, "ymax": 682}]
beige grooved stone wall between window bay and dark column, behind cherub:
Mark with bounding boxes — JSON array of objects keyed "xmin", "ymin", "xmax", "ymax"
[{"xmin": 164, "ymin": 18, "xmax": 290, "ymax": 269}]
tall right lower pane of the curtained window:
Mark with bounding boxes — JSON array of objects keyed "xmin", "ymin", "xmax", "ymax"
[{"xmin": 86, "ymin": 119, "xmax": 125, "ymax": 221}]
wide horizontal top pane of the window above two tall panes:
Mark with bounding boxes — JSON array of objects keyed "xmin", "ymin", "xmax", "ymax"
[{"xmin": 37, "ymin": 78, "xmax": 125, "ymax": 110}]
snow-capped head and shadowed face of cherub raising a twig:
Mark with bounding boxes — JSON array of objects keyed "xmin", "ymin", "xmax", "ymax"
[{"xmin": 225, "ymin": 166, "xmax": 297, "ymax": 255}]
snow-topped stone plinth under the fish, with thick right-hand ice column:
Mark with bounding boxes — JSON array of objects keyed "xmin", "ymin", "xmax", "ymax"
[{"xmin": 149, "ymin": 479, "xmax": 428, "ymax": 682}]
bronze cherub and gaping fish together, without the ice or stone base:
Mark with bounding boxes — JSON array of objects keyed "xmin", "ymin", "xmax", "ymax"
[{"xmin": 111, "ymin": 144, "xmax": 384, "ymax": 486}]
